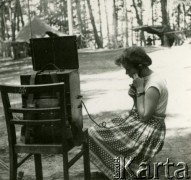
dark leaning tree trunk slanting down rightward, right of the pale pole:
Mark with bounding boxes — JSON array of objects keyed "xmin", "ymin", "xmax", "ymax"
[{"xmin": 87, "ymin": 0, "xmax": 103, "ymax": 48}]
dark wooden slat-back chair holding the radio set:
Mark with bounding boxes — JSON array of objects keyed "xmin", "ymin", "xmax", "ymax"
[{"xmin": 0, "ymin": 83, "xmax": 90, "ymax": 180}]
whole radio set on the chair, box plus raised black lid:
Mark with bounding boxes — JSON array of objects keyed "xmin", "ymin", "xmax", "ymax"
[{"xmin": 20, "ymin": 36, "xmax": 83, "ymax": 144}]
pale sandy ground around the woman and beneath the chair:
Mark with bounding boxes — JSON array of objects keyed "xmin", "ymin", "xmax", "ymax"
[{"xmin": 0, "ymin": 43, "xmax": 191, "ymax": 180}]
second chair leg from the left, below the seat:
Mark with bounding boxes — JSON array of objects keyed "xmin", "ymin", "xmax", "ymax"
[{"xmin": 34, "ymin": 154, "xmax": 43, "ymax": 180}]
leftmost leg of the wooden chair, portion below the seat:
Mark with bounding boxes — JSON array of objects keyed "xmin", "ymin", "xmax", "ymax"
[{"xmin": 9, "ymin": 153, "xmax": 17, "ymax": 180}]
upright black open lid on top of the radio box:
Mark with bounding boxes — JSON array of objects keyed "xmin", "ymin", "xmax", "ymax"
[{"xmin": 30, "ymin": 36, "xmax": 79, "ymax": 71}]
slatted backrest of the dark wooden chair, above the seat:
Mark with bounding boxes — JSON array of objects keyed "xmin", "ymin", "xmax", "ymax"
[{"xmin": 0, "ymin": 83, "xmax": 67, "ymax": 148}]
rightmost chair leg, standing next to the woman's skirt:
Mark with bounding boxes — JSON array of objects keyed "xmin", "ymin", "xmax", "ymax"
[{"xmin": 83, "ymin": 142, "xmax": 91, "ymax": 180}]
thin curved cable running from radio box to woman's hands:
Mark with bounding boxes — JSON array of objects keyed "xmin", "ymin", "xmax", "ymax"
[{"xmin": 81, "ymin": 100, "xmax": 135, "ymax": 129}]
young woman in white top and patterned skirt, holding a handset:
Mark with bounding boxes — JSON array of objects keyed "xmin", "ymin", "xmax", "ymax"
[{"xmin": 89, "ymin": 47, "xmax": 168, "ymax": 179}]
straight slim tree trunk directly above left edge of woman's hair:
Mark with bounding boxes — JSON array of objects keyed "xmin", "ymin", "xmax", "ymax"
[{"xmin": 112, "ymin": 0, "xmax": 118, "ymax": 48}]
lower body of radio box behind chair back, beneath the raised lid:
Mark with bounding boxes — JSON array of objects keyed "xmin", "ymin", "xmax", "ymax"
[{"xmin": 20, "ymin": 69, "xmax": 83, "ymax": 145}]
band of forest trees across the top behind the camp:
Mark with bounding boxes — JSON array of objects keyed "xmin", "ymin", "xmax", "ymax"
[{"xmin": 0, "ymin": 0, "xmax": 191, "ymax": 54}]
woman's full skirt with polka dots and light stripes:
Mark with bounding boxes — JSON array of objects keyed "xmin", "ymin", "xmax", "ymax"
[{"xmin": 89, "ymin": 110, "xmax": 166, "ymax": 179}]
